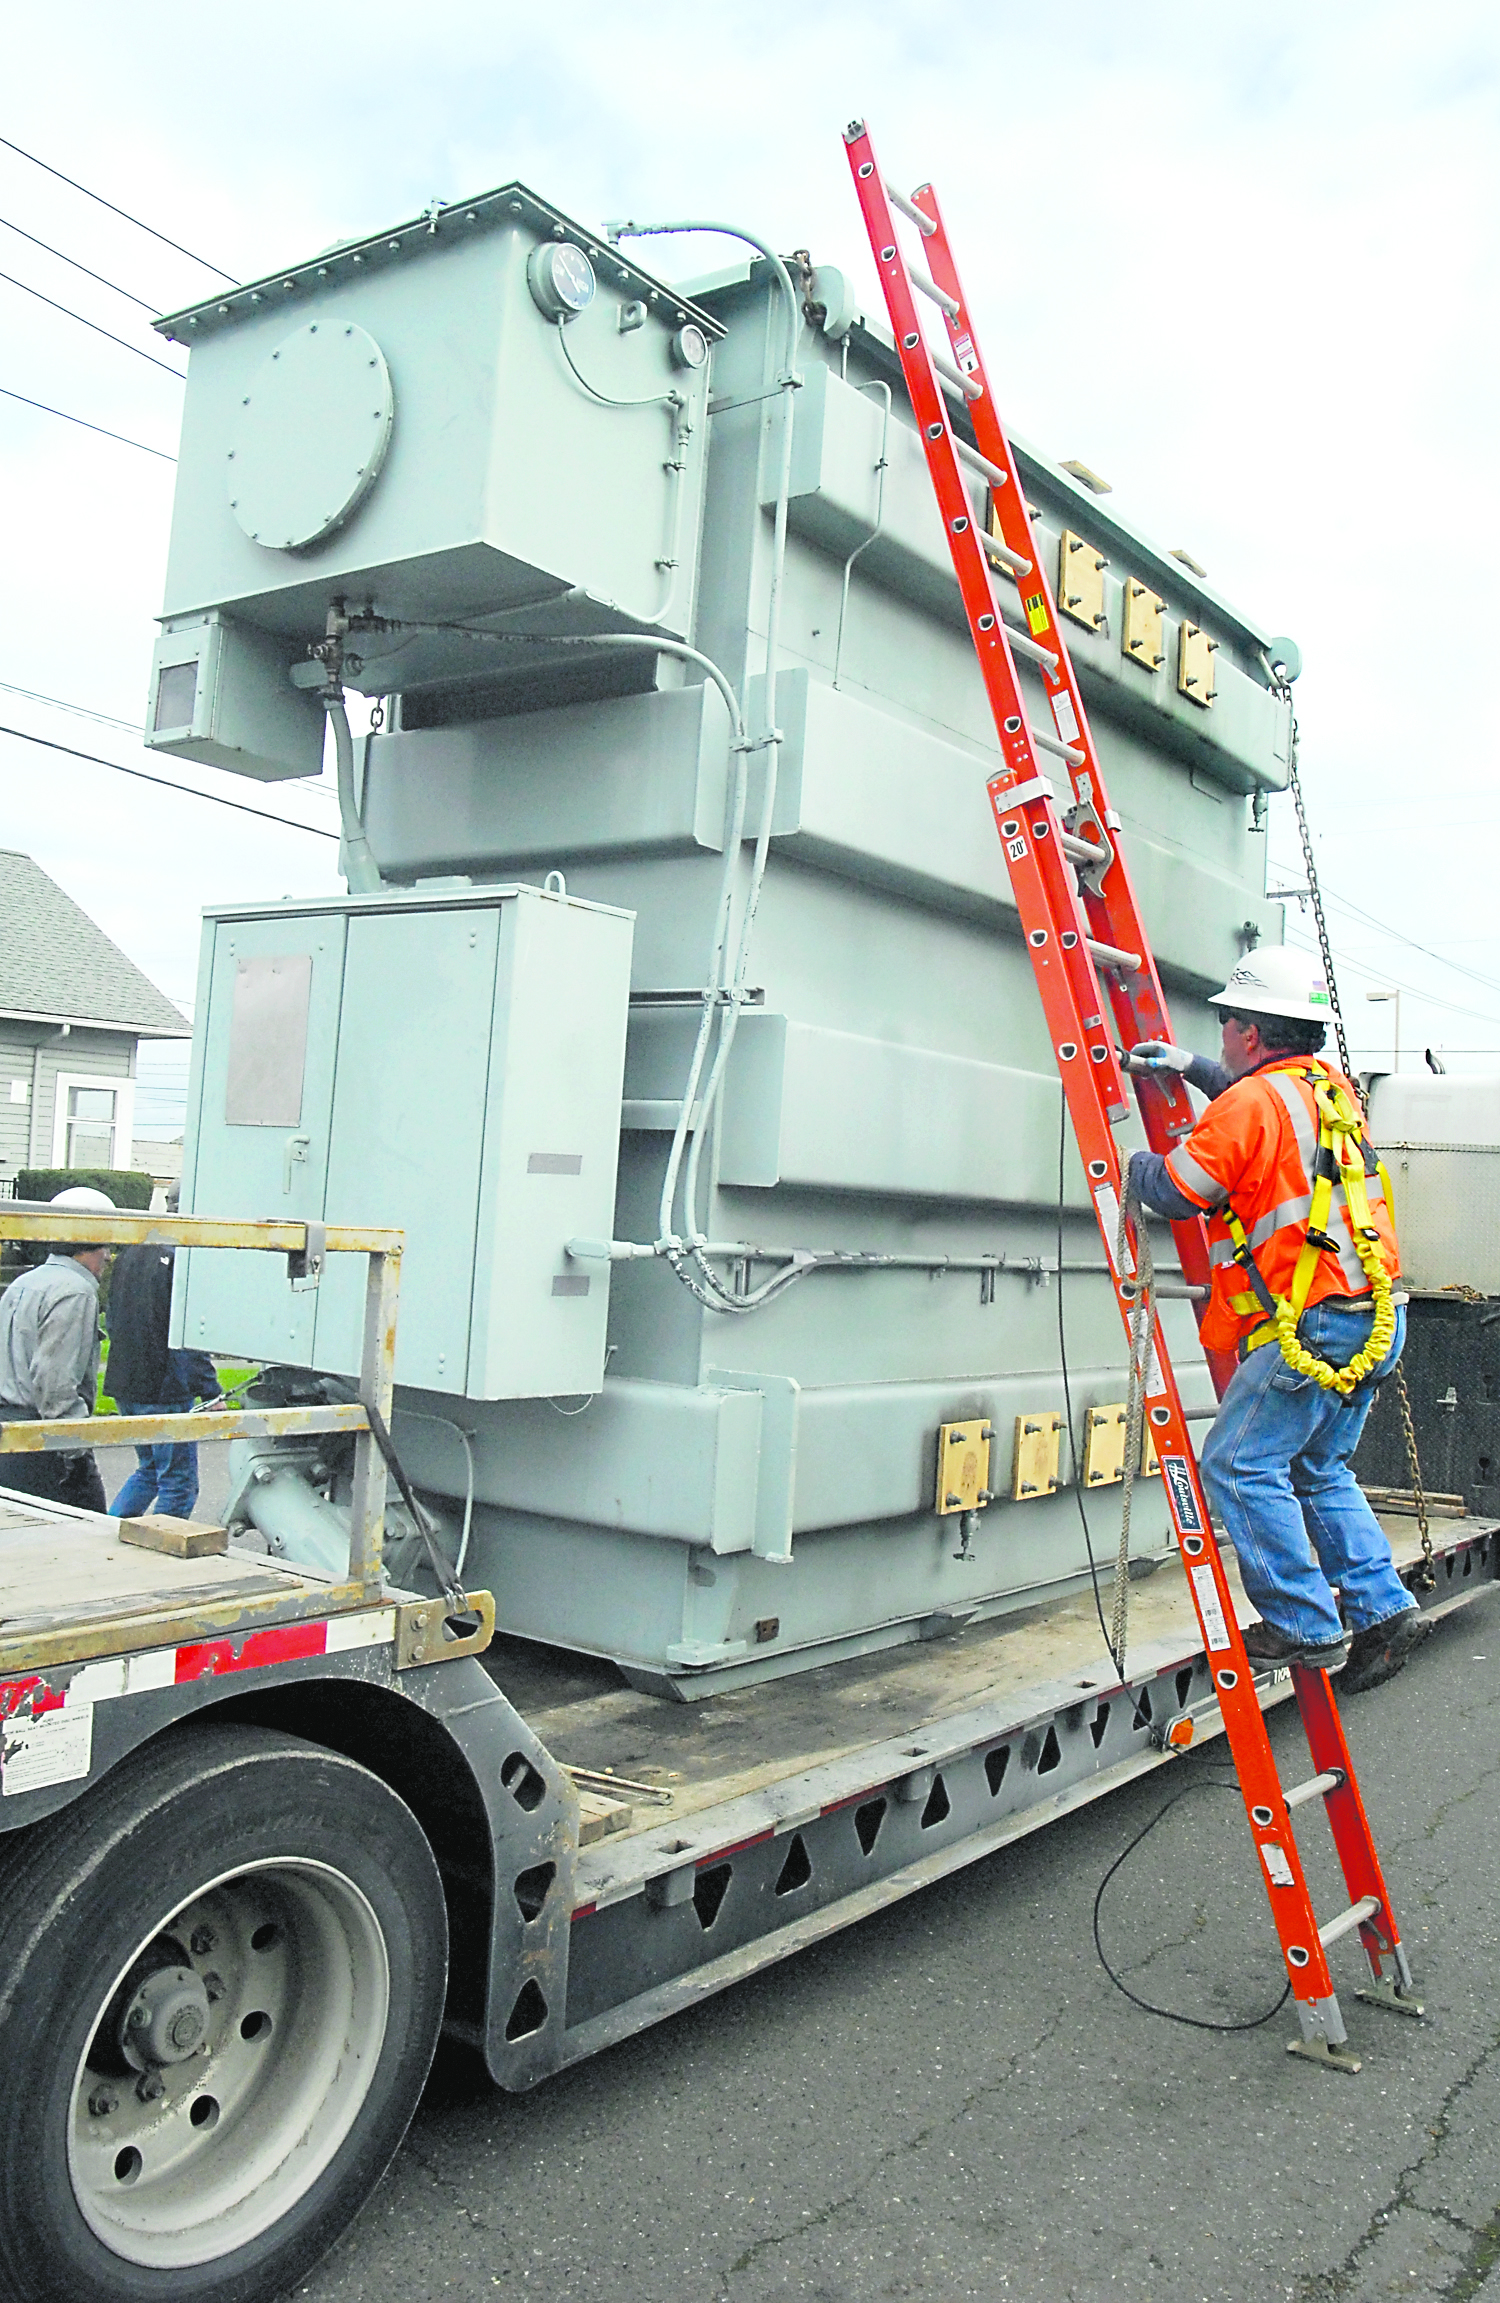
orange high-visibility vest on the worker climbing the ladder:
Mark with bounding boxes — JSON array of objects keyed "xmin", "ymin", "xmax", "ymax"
[{"xmin": 1166, "ymin": 1055, "xmax": 1401, "ymax": 1352}]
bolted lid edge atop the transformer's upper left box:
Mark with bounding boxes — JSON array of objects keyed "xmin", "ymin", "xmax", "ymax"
[{"xmin": 152, "ymin": 182, "xmax": 724, "ymax": 345}]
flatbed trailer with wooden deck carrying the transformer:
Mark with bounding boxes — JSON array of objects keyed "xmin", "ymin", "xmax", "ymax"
[{"xmin": 0, "ymin": 1218, "xmax": 1500, "ymax": 2303}]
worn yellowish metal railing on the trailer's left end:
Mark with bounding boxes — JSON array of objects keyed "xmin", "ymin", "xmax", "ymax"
[{"xmin": 0, "ymin": 1202, "xmax": 406, "ymax": 1612}]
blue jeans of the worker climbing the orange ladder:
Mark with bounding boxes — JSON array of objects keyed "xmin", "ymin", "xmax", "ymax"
[{"xmin": 1203, "ymin": 1301, "xmax": 1417, "ymax": 1647}]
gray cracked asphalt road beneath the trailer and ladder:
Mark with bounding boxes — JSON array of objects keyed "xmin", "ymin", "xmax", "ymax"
[{"xmin": 273, "ymin": 1591, "xmax": 1500, "ymax": 2303}]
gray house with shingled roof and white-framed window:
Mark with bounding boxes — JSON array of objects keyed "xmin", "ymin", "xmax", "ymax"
[{"xmin": 0, "ymin": 850, "xmax": 191, "ymax": 1193}]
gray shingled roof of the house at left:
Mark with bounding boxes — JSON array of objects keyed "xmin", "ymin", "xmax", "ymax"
[{"xmin": 0, "ymin": 848, "xmax": 191, "ymax": 1039}]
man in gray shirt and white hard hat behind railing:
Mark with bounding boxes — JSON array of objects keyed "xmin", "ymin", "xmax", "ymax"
[{"xmin": 0, "ymin": 1184, "xmax": 115, "ymax": 1511}]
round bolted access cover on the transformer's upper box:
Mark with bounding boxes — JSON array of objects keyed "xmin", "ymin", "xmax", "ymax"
[{"xmin": 228, "ymin": 320, "xmax": 396, "ymax": 553}]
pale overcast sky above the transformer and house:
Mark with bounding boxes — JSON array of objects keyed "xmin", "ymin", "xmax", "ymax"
[{"xmin": 0, "ymin": 0, "xmax": 1500, "ymax": 1128}]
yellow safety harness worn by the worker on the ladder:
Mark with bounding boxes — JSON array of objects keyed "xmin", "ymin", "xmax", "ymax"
[{"xmin": 1224, "ymin": 1071, "xmax": 1396, "ymax": 1398}]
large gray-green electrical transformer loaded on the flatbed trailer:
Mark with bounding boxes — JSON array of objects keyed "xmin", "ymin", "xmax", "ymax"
[{"xmin": 158, "ymin": 184, "xmax": 1295, "ymax": 1695}]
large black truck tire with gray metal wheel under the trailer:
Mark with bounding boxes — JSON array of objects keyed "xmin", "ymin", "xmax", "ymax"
[{"xmin": 0, "ymin": 1725, "xmax": 447, "ymax": 2303}]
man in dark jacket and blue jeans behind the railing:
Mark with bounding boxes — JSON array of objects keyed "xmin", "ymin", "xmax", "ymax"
[{"xmin": 108, "ymin": 1191, "xmax": 224, "ymax": 1520}]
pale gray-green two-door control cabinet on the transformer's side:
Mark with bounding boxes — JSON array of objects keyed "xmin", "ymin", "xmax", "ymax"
[{"xmin": 175, "ymin": 887, "xmax": 631, "ymax": 1400}]
